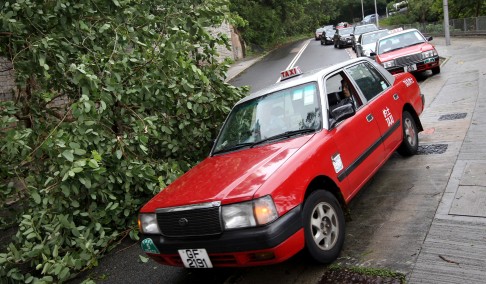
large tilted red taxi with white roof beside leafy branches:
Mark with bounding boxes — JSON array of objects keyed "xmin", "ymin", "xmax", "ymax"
[{"xmin": 139, "ymin": 58, "xmax": 424, "ymax": 268}]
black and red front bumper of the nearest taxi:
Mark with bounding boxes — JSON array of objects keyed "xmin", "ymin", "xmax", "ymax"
[{"xmin": 141, "ymin": 206, "xmax": 305, "ymax": 267}]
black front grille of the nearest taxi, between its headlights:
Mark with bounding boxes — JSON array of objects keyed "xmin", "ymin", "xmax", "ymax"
[{"xmin": 157, "ymin": 206, "xmax": 223, "ymax": 237}]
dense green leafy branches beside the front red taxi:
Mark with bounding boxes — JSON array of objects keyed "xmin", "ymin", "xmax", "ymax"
[{"xmin": 0, "ymin": 0, "xmax": 243, "ymax": 283}]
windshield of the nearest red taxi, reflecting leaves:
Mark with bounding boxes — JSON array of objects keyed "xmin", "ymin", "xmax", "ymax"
[{"xmin": 213, "ymin": 82, "xmax": 322, "ymax": 153}]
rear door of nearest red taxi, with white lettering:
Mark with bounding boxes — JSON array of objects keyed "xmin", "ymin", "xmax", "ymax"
[{"xmin": 347, "ymin": 62, "xmax": 403, "ymax": 156}]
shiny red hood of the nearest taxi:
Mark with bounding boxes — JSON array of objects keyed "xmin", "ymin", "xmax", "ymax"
[{"xmin": 142, "ymin": 135, "xmax": 313, "ymax": 212}]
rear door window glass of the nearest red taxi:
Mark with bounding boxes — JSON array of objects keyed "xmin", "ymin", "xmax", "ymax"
[{"xmin": 347, "ymin": 63, "xmax": 390, "ymax": 101}]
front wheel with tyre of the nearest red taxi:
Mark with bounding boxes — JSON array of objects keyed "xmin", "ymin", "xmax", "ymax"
[{"xmin": 303, "ymin": 190, "xmax": 345, "ymax": 263}]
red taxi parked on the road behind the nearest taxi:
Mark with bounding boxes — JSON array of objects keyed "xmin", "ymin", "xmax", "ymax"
[{"xmin": 371, "ymin": 29, "xmax": 440, "ymax": 74}]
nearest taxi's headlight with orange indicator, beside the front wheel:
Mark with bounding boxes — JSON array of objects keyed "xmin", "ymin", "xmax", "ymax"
[{"xmin": 222, "ymin": 195, "xmax": 278, "ymax": 229}]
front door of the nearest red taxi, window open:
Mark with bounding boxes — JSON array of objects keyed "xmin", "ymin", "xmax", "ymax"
[{"xmin": 325, "ymin": 72, "xmax": 384, "ymax": 199}]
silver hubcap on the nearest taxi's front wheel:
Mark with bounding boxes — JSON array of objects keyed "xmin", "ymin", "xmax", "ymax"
[{"xmin": 310, "ymin": 202, "xmax": 339, "ymax": 250}]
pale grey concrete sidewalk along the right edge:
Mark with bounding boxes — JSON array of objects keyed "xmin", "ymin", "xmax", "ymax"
[{"xmin": 408, "ymin": 38, "xmax": 486, "ymax": 283}]
